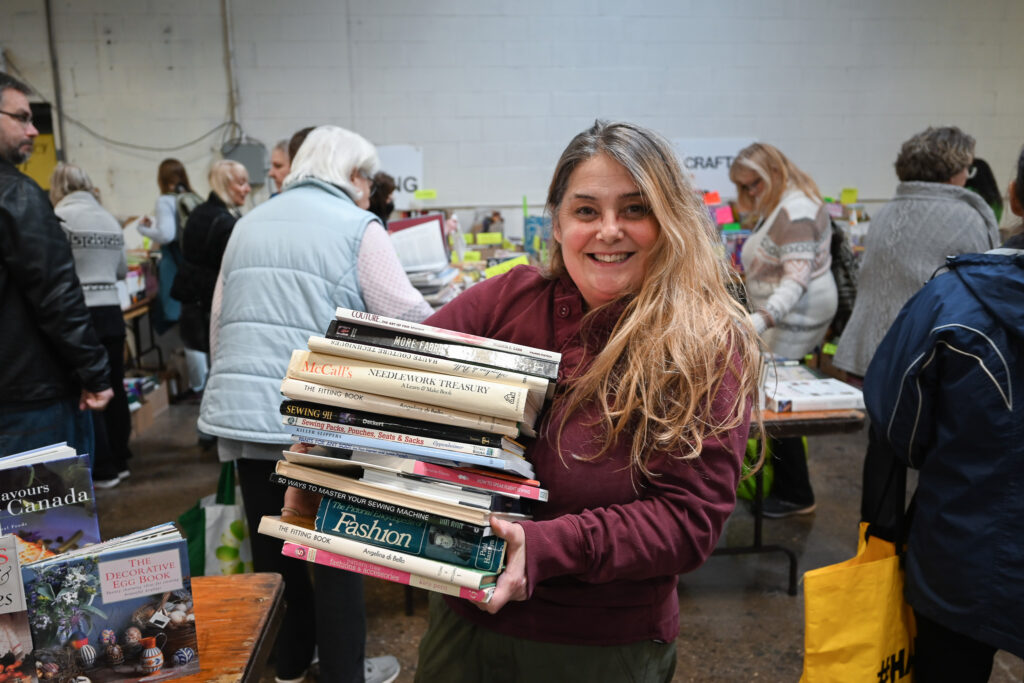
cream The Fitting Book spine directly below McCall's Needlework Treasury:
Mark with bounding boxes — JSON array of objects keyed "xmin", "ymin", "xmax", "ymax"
[{"xmin": 281, "ymin": 378, "xmax": 519, "ymax": 436}]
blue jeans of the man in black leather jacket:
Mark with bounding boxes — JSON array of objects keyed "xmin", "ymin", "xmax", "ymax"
[{"xmin": 0, "ymin": 398, "xmax": 95, "ymax": 456}]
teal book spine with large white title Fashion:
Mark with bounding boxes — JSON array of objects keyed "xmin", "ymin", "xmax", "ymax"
[{"xmin": 316, "ymin": 498, "xmax": 505, "ymax": 572}]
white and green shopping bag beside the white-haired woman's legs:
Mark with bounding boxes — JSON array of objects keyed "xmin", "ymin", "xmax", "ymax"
[{"xmin": 178, "ymin": 463, "xmax": 253, "ymax": 577}]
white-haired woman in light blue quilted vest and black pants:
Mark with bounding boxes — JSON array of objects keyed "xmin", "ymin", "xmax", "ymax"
[{"xmin": 199, "ymin": 126, "xmax": 423, "ymax": 683}]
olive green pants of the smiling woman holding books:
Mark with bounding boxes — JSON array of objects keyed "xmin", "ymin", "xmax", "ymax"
[{"xmin": 416, "ymin": 593, "xmax": 676, "ymax": 683}]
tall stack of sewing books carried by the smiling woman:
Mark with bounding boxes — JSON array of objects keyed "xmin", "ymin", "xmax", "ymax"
[{"xmin": 259, "ymin": 309, "xmax": 560, "ymax": 602}]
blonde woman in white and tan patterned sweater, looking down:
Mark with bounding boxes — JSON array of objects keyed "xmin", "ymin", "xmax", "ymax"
[{"xmin": 729, "ymin": 142, "xmax": 838, "ymax": 517}]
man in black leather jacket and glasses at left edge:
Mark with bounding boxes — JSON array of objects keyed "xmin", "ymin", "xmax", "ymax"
[{"xmin": 0, "ymin": 73, "xmax": 114, "ymax": 456}]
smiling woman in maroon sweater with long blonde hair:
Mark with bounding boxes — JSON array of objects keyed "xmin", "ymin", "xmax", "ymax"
[{"xmin": 417, "ymin": 122, "xmax": 760, "ymax": 682}]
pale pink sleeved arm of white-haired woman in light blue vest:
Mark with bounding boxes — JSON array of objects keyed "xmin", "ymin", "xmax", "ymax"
[{"xmin": 357, "ymin": 221, "xmax": 434, "ymax": 323}]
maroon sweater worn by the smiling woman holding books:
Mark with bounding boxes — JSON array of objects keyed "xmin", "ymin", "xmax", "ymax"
[{"xmin": 427, "ymin": 266, "xmax": 750, "ymax": 645}]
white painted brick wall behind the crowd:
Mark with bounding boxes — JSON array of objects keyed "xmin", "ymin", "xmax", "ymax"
[{"xmin": 0, "ymin": 0, "xmax": 1024, "ymax": 218}]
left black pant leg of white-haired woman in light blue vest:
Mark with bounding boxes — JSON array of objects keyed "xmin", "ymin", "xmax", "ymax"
[{"xmin": 237, "ymin": 458, "xmax": 315, "ymax": 680}]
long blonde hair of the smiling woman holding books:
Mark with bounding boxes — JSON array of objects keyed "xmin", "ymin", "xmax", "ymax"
[{"xmin": 547, "ymin": 121, "xmax": 761, "ymax": 477}]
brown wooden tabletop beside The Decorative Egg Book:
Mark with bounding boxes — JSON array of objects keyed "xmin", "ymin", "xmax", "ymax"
[{"xmin": 177, "ymin": 572, "xmax": 285, "ymax": 683}]
